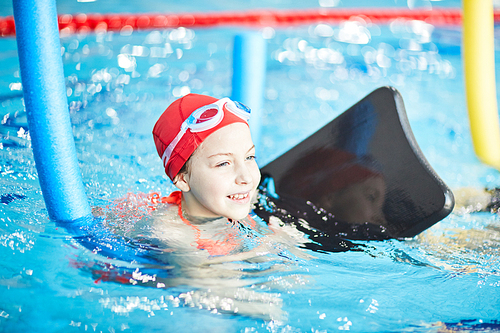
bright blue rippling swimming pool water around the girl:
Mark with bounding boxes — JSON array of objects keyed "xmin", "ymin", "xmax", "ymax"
[{"xmin": 0, "ymin": 1, "xmax": 500, "ymax": 332}]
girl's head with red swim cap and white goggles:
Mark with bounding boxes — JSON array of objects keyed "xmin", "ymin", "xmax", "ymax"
[{"xmin": 153, "ymin": 94, "xmax": 260, "ymax": 220}]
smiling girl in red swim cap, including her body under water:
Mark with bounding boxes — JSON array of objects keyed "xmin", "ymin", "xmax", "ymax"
[{"xmin": 143, "ymin": 94, "xmax": 306, "ymax": 319}]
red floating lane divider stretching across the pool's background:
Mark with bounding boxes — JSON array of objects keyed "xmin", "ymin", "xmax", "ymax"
[{"xmin": 0, "ymin": 8, "xmax": 500, "ymax": 36}]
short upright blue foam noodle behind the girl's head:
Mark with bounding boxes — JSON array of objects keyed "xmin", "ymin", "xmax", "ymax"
[{"xmin": 231, "ymin": 32, "xmax": 266, "ymax": 151}]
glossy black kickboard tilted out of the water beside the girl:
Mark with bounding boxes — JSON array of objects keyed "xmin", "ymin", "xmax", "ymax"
[{"xmin": 256, "ymin": 87, "xmax": 454, "ymax": 239}]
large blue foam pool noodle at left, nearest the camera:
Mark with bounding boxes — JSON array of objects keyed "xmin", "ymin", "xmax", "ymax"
[{"xmin": 13, "ymin": 0, "xmax": 91, "ymax": 222}]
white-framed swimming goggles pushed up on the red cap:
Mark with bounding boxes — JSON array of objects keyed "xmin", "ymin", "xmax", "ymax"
[{"xmin": 162, "ymin": 97, "xmax": 250, "ymax": 166}]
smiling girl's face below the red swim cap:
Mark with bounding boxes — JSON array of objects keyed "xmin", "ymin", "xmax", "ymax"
[{"xmin": 174, "ymin": 123, "xmax": 260, "ymax": 220}]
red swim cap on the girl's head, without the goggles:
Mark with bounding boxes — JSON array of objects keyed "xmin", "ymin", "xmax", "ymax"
[{"xmin": 153, "ymin": 94, "xmax": 248, "ymax": 180}]
